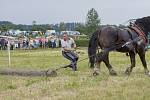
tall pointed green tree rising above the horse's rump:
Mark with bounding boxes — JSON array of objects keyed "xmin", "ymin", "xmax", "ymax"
[{"xmin": 86, "ymin": 8, "xmax": 100, "ymax": 37}]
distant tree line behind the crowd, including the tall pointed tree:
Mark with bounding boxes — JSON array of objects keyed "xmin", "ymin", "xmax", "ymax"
[{"xmin": 0, "ymin": 8, "xmax": 123, "ymax": 37}]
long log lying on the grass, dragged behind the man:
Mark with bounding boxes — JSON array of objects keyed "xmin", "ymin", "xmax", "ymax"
[{"xmin": 0, "ymin": 69, "xmax": 57, "ymax": 77}]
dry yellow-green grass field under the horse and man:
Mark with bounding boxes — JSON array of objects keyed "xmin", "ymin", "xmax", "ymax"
[{"xmin": 0, "ymin": 48, "xmax": 150, "ymax": 100}]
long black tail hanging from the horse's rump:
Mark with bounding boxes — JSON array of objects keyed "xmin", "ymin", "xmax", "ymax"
[{"xmin": 88, "ymin": 31, "xmax": 99, "ymax": 68}]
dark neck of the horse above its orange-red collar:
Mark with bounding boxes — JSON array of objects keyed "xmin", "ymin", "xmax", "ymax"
[{"xmin": 135, "ymin": 16, "xmax": 150, "ymax": 35}]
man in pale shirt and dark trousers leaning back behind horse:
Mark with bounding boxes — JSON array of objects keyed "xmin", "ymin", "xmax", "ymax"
[{"xmin": 61, "ymin": 33, "xmax": 79, "ymax": 71}]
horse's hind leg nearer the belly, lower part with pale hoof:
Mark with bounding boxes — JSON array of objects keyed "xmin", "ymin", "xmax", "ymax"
[{"xmin": 103, "ymin": 53, "xmax": 117, "ymax": 75}]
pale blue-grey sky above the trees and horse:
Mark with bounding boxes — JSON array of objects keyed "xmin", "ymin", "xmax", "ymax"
[{"xmin": 0, "ymin": 0, "xmax": 150, "ymax": 24}]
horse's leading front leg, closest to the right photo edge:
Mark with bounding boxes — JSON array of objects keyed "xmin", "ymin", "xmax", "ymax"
[{"xmin": 138, "ymin": 51, "xmax": 150, "ymax": 75}]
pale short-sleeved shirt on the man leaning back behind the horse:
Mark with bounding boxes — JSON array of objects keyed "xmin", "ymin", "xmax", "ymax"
[{"xmin": 61, "ymin": 38, "xmax": 75, "ymax": 51}]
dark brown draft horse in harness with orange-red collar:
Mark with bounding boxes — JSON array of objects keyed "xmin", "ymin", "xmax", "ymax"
[{"xmin": 88, "ymin": 16, "xmax": 150, "ymax": 75}]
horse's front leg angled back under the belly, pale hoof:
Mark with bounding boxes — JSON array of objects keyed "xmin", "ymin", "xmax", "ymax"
[{"xmin": 125, "ymin": 51, "xmax": 135, "ymax": 75}]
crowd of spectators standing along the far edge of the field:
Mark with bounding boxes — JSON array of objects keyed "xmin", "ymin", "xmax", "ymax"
[{"xmin": 0, "ymin": 35, "xmax": 60, "ymax": 50}]
